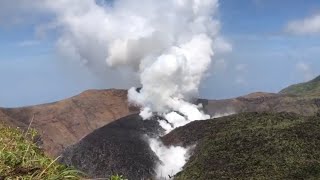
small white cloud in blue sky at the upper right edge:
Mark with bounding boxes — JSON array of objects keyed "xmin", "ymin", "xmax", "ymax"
[{"xmin": 285, "ymin": 14, "xmax": 320, "ymax": 35}]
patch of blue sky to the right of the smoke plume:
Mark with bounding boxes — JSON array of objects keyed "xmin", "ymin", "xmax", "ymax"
[{"xmin": 203, "ymin": 0, "xmax": 320, "ymax": 99}]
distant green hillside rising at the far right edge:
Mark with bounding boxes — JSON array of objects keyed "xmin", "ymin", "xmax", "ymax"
[{"xmin": 280, "ymin": 76, "xmax": 320, "ymax": 96}]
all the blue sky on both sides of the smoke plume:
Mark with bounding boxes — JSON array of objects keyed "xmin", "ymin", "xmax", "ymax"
[{"xmin": 0, "ymin": 0, "xmax": 320, "ymax": 107}]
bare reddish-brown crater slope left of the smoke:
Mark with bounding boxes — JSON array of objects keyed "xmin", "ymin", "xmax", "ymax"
[{"xmin": 0, "ymin": 89, "xmax": 137, "ymax": 156}]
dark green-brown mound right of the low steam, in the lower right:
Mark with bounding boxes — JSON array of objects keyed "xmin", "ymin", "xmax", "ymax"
[{"xmin": 175, "ymin": 113, "xmax": 320, "ymax": 180}]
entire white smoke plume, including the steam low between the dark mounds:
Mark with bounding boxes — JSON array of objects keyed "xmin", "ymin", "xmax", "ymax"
[{"xmin": 4, "ymin": 0, "xmax": 232, "ymax": 176}]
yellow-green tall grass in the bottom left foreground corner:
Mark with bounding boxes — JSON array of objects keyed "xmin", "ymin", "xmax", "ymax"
[{"xmin": 0, "ymin": 124, "xmax": 82, "ymax": 180}]
